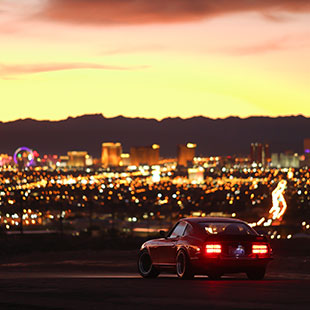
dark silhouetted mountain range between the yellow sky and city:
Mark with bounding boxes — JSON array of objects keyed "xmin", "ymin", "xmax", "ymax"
[{"xmin": 0, "ymin": 114, "xmax": 310, "ymax": 157}]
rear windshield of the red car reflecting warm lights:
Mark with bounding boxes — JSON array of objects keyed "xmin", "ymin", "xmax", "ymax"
[{"xmin": 199, "ymin": 222, "xmax": 257, "ymax": 235}]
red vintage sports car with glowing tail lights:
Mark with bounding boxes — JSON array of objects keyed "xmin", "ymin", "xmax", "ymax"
[{"xmin": 138, "ymin": 217, "xmax": 272, "ymax": 280}]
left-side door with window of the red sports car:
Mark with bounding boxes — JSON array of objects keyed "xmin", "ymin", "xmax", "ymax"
[{"xmin": 157, "ymin": 221, "xmax": 187, "ymax": 265}]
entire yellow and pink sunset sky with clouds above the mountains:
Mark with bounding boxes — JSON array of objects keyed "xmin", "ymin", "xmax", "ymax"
[{"xmin": 0, "ymin": 0, "xmax": 310, "ymax": 121}]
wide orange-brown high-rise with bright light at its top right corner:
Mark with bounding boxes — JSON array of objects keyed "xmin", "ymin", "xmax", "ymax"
[{"xmin": 130, "ymin": 144, "xmax": 160, "ymax": 166}]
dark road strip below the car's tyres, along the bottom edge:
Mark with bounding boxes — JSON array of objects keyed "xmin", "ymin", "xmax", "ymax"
[{"xmin": 0, "ymin": 270, "xmax": 310, "ymax": 310}]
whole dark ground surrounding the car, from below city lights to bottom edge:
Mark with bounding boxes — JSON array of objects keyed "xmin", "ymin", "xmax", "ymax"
[{"xmin": 0, "ymin": 246, "xmax": 310, "ymax": 310}]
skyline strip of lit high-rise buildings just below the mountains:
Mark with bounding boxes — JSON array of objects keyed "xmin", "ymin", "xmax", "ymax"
[{"xmin": 0, "ymin": 138, "xmax": 310, "ymax": 170}]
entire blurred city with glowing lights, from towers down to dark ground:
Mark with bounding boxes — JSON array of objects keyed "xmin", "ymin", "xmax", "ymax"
[{"xmin": 0, "ymin": 138, "xmax": 310, "ymax": 239}]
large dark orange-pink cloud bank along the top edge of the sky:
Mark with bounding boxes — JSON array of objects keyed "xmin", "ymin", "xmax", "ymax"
[{"xmin": 39, "ymin": 0, "xmax": 310, "ymax": 25}]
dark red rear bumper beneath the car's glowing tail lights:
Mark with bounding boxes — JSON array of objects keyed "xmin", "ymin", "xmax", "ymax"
[{"xmin": 191, "ymin": 257, "xmax": 272, "ymax": 273}]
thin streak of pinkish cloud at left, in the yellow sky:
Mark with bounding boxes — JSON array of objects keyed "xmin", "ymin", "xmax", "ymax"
[{"xmin": 0, "ymin": 63, "xmax": 148, "ymax": 78}]
